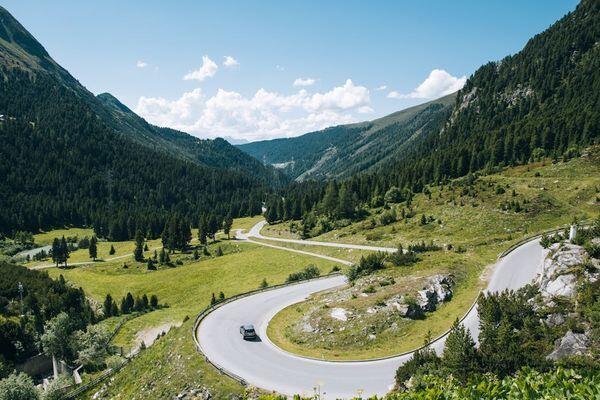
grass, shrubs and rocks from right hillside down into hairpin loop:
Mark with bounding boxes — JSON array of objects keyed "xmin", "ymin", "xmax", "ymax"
[{"xmin": 262, "ymin": 152, "xmax": 600, "ymax": 359}]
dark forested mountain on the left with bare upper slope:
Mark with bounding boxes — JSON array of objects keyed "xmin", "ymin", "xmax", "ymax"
[{"xmin": 0, "ymin": 7, "xmax": 270, "ymax": 234}]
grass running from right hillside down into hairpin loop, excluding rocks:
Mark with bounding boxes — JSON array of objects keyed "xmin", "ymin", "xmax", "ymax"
[{"xmin": 262, "ymin": 153, "xmax": 600, "ymax": 360}]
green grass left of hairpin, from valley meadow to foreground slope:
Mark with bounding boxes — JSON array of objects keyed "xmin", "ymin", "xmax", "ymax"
[{"xmin": 34, "ymin": 225, "xmax": 336, "ymax": 399}]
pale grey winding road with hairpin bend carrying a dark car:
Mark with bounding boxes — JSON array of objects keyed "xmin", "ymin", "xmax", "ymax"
[{"xmin": 195, "ymin": 222, "xmax": 546, "ymax": 399}]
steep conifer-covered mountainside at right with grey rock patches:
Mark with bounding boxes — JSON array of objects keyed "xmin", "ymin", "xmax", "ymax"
[{"xmin": 365, "ymin": 0, "xmax": 600, "ymax": 189}]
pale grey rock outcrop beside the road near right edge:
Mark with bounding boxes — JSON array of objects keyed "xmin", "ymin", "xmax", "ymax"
[{"xmin": 539, "ymin": 243, "xmax": 587, "ymax": 299}]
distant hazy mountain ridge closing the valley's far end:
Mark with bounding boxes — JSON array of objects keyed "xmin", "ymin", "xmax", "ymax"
[{"xmin": 238, "ymin": 94, "xmax": 456, "ymax": 181}]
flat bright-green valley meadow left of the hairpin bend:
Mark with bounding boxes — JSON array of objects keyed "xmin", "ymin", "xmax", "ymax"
[{"xmin": 48, "ymin": 243, "xmax": 335, "ymax": 346}]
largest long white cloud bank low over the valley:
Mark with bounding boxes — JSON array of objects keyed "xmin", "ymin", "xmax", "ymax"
[{"xmin": 135, "ymin": 79, "xmax": 373, "ymax": 140}]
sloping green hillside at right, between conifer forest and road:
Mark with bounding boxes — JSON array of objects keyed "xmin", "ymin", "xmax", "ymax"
[{"xmin": 262, "ymin": 153, "xmax": 600, "ymax": 247}]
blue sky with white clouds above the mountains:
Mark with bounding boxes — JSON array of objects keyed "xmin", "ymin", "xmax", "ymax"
[{"xmin": 0, "ymin": 0, "xmax": 577, "ymax": 143}]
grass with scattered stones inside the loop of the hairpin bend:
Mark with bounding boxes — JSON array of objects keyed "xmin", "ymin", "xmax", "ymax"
[{"xmin": 267, "ymin": 248, "xmax": 498, "ymax": 360}]
